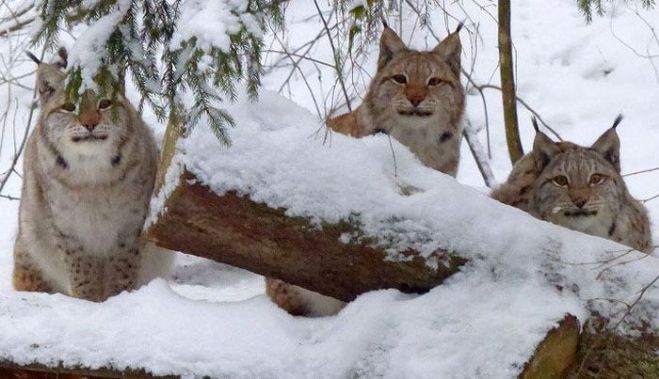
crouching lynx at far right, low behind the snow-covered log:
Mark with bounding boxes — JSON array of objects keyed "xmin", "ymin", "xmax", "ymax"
[{"xmin": 492, "ymin": 116, "xmax": 652, "ymax": 253}]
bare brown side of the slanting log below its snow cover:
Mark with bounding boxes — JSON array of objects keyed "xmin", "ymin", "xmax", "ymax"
[{"xmin": 147, "ymin": 172, "xmax": 465, "ymax": 301}]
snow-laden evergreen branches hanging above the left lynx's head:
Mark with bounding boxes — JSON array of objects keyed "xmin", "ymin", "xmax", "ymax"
[{"xmin": 34, "ymin": 0, "xmax": 282, "ymax": 143}]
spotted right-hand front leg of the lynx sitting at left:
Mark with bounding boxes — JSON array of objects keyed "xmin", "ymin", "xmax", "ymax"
[{"xmin": 106, "ymin": 246, "xmax": 140, "ymax": 297}]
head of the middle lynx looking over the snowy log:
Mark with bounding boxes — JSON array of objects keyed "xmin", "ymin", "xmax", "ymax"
[{"xmin": 369, "ymin": 28, "xmax": 464, "ymax": 129}]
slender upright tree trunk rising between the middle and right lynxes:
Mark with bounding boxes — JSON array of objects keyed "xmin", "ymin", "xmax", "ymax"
[{"xmin": 499, "ymin": 0, "xmax": 524, "ymax": 164}]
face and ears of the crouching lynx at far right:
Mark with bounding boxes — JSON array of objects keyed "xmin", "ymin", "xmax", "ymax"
[{"xmin": 530, "ymin": 121, "xmax": 627, "ymax": 238}]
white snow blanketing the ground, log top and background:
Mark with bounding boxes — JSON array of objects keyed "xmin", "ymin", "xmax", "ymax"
[{"xmin": 0, "ymin": 0, "xmax": 659, "ymax": 378}]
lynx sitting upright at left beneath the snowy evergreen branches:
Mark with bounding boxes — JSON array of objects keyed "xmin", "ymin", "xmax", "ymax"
[{"xmin": 13, "ymin": 50, "xmax": 164, "ymax": 301}]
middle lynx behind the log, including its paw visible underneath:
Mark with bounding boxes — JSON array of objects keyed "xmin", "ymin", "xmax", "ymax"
[{"xmin": 266, "ymin": 24, "xmax": 465, "ymax": 316}]
